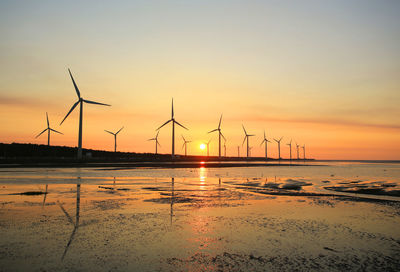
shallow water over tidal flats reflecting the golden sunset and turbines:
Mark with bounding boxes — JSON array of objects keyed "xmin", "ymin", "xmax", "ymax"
[{"xmin": 0, "ymin": 163, "xmax": 400, "ymax": 271}]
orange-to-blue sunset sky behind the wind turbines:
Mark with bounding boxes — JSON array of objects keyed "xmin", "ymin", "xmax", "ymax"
[{"xmin": 0, "ymin": 0, "xmax": 400, "ymax": 160}]
